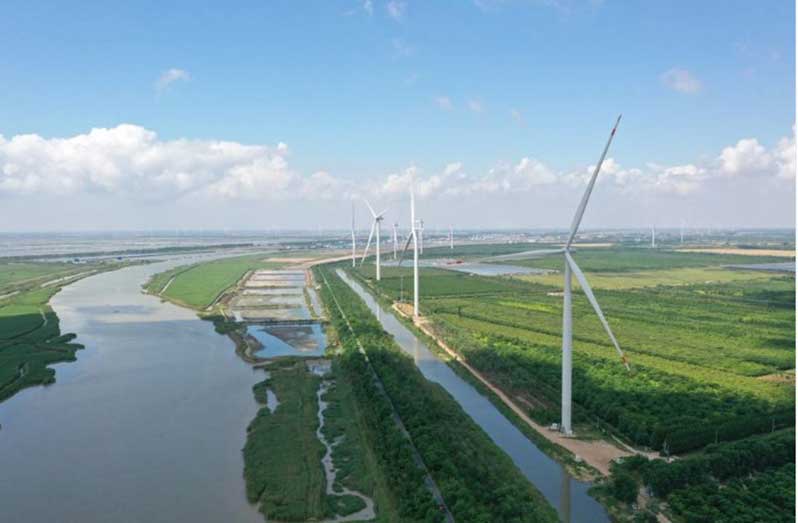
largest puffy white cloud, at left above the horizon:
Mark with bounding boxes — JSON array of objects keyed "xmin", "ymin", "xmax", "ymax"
[{"xmin": 0, "ymin": 124, "xmax": 302, "ymax": 199}]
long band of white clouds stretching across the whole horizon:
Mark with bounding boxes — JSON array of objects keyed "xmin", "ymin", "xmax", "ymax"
[{"xmin": 0, "ymin": 124, "xmax": 796, "ymax": 214}]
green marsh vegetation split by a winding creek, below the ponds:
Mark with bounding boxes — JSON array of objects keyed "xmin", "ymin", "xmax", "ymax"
[{"xmin": 244, "ymin": 359, "xmax": 376, "ymax": 521}]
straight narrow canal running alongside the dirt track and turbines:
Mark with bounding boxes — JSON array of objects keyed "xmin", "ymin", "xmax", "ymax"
[{"xmin": 337, "ymin": 269, "xmax": 609, "ymax": 523}]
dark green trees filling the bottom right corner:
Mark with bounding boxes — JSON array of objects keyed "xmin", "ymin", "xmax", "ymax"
[{"xmin": 611, "ymin": 429, "xmax": 795, "ymax": 523}]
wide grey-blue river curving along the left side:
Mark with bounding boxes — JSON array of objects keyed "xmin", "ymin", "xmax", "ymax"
[{"xmin": 0, "ymin": 257, "xmax": 263, "ymax": 523}]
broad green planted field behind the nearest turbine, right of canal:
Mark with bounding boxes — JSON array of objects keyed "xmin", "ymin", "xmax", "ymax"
[{"xmin": 360, "ymin": 249, "xmax": 795, "ymax": 452}]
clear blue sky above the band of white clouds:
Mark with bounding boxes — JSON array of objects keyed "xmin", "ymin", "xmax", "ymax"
[{"xmin": 0, "ymin": 0, "xmax": 795, "ymax": 227}]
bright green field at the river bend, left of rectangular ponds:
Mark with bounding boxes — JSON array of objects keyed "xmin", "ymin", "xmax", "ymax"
[{"xmin": 144, "ymin": 253, "xmax": 282, "ymax": 310}]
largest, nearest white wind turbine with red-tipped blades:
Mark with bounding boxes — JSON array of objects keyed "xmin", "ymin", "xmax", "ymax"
[{"xmin": 489, "ymin": 116, "xmax": 630, "ymax": 435}]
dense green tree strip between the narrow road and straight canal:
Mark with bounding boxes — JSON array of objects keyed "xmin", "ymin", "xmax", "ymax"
[{"xmin": 318, "ymin": 268, "xmax": 557, "ymax": 522}]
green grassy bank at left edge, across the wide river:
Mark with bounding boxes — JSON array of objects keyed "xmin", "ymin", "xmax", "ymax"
[{"xmin": 0, "ymin": 261, "xmax": 125, "ymax": 401}]
